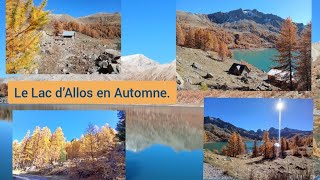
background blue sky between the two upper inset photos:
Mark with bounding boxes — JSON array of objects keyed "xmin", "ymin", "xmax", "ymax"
[{"xmin": 121, "ymin": 0, "xmax": 176, "ymax": 63}]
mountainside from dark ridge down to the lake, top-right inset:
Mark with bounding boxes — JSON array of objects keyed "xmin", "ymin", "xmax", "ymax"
[{"xmin": 177, "ymin": 9, "xmax": 304, "ymax": 49}]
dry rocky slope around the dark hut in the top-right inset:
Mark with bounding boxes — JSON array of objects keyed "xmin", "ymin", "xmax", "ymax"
[{"xmin": 177, "ymin": 47, "xmax": 278, "ymax": 91}]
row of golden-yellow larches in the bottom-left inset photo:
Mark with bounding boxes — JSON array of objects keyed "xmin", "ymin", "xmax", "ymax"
[{"xmin": 13, "ymin": 125, "xmax": 119, "ymax": 169}]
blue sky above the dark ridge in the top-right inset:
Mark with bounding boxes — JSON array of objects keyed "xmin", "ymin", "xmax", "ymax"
[{"xmin": 177, "ymin": 0, "xmax": 311, "ymax": 23}]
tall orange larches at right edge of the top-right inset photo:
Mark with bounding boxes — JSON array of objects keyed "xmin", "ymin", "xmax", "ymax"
[{"xmin": 274, "ymin": 18, "xmax": 312, "ymax": 91}]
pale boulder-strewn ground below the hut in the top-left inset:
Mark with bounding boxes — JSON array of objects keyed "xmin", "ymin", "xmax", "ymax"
[{"xmin": 32, "ymin": 31, "xmax": 121, "ymax": 74}]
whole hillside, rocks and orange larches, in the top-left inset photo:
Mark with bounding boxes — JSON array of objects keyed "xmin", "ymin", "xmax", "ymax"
[{"xmin": 33, "ymin": 13, "xmax": 121, "ymax": 74}]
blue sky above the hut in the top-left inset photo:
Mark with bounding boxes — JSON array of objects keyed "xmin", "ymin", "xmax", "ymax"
[{"xmin": 34, "ymin": 0, "xmax": 121, "ymax": 17}]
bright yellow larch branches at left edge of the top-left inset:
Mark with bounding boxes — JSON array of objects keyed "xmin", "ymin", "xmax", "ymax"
[{"xmin": 6, "ymin": 0, "xmax": 49, "ymax": 74}]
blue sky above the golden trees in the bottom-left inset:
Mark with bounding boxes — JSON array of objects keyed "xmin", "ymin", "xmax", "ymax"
[{"xmin": 12, "ymin": 110, "xmax": 118, "ymax": 141}]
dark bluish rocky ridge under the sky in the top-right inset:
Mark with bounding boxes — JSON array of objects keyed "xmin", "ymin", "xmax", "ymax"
[{"xmin": 208, "ymin": 9, "xmax": 304, "ymax": 32}]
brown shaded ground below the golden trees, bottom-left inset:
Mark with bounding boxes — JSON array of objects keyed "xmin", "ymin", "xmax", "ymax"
[{"xmin": 13, "ymin": 143, "xmax": 126, "ymax": 180}]
